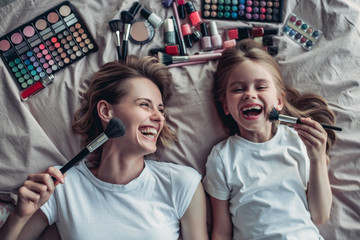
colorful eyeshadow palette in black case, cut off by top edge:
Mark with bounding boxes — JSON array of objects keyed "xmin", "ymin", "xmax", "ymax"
[{"xmin": 202, "ymin": 0, "xmax": 283, "ymax": 23}]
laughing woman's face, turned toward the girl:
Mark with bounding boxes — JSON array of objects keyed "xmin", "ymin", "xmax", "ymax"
[{"xmin": 114, "ymin": 78, "xmax": 165, "ymax": 155}]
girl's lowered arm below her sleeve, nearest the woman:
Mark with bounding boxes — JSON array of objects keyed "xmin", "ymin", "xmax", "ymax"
[{"xmin": 210, "ymin": 196, "xmax": 233, "ymax": 240}]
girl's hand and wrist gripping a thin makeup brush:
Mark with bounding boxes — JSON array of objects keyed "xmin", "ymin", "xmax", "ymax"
[{"xmin": 294, "ymin": 117, "xmax": 327, "ymax": 162}]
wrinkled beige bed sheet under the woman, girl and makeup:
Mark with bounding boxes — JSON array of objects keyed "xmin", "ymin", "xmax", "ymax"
[{"xmin": 0, "ymin": 0, "xmax": 360, "ymax": 239}]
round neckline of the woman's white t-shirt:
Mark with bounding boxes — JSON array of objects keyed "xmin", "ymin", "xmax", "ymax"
[{"xmin": 78, "ymin": 161, "xmax": 149, "ymax": 192}]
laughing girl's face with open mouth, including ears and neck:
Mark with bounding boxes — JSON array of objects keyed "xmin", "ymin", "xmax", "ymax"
[{"xmin": 223, "ymin": 61, "xmax": 283, "ymax": 142}]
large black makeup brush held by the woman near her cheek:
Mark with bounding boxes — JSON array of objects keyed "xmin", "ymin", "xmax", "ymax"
[{"xmin": 52, "ymin": 118, "xmax": 125, "ymax": 181}]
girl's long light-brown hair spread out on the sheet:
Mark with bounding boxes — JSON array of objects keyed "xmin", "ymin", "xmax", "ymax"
[{"xmin": 213, "ymin": 39, "xmax": 336, "ymax": 156}]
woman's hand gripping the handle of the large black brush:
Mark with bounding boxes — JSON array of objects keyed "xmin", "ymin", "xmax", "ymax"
[{"xmin": 14, "ymin": 167, "xmax": 64, "ymax": 217}]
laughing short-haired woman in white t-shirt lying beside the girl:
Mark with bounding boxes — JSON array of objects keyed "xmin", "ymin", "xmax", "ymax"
[{"xmin": 0, "ymin": 56, "xmax": 207, "ymax": 240}]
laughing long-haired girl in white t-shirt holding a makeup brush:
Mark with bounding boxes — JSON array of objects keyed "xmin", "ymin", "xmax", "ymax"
[{"xmin": 204, "ymin": 40, "xmax": 335, "ymax": 240}]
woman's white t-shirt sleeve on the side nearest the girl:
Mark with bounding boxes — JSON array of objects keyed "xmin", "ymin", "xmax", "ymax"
[{"xmin": 170, "ymin": 165, "xmax": 201, "ymax": 219}]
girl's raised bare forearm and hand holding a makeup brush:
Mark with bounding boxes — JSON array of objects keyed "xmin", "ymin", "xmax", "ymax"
[{"xmin": 295, "ymin": 118, "xmax": 332, "ymax": 224}]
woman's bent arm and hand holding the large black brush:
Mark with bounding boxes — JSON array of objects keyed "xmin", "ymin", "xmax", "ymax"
[{"xmin": 0, "ymin": 167, "xmax": 64, "ymax": 240}]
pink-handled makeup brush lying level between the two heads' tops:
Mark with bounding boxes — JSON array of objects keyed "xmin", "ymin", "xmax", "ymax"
[{"xmin": 158, "ymin": 52, "xmax": 221, "ymax": 65}]
